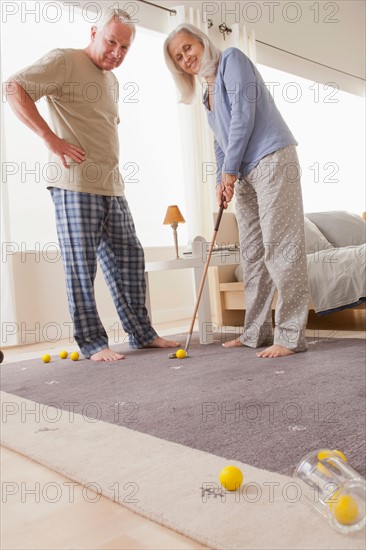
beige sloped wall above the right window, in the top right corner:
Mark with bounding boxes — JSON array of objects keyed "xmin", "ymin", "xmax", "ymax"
[{"xmin": 160, "ymin": 0, "xmax": 366, "ymax": 93}]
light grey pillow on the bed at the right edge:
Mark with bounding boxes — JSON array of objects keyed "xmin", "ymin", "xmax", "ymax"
[{"xmin": 306, "ymin": 210, "xmax": 366, "ymax": 247}]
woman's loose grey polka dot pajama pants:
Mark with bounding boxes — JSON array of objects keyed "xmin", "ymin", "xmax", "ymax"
[{"xmin": 235, "ymin": 145, "xmax": 310, "ymax": 351}]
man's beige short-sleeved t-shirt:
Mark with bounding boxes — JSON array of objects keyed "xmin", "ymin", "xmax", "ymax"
[{"xmin": 11, "ymin": 49, "xmax": 124, "ymax": 196}]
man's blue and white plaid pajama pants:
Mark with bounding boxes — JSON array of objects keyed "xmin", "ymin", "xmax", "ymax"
[{"xmin": 51, "ymin": 187, "xmax": 157, "ymax": 358}]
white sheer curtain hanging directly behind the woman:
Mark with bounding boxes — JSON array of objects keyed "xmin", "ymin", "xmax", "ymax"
[{"xmin": 169, "ymin": 6, "xmax": 256, "ymax": 240}]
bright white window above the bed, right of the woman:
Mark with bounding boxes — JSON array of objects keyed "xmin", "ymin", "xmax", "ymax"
[{"xmin": 258, "ymin": 65, "xmax": 365, "ymax": 214}]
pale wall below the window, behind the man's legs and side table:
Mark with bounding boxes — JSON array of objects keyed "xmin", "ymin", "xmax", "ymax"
[{"xmin": 1, "ymin": 247, "xmax": 194, "ymax": 347}]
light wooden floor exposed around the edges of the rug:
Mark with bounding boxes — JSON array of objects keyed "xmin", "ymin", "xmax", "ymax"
[{"xmin": 0, "ymin": 321, "xmax": 365, "ymax": 550}]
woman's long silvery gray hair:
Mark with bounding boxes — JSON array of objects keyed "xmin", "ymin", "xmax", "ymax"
[{"xmin": 164, "ymin": 23, "xmax": 221, "ymax": 104}]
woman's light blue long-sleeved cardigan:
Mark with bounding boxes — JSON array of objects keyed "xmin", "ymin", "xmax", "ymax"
[{"xmin": 203, "ymin": 48, "xmax": 297, "ymax": 184}]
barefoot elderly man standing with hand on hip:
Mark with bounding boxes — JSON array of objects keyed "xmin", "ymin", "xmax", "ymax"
[{"xmin": 7, "ymin": 9, "xmax": 179, "ymax": 361}]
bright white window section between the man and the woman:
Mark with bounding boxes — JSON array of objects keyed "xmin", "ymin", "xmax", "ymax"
[{"xmin": 116, "ymin": 29, "xmax": 187, "ymax": 246}]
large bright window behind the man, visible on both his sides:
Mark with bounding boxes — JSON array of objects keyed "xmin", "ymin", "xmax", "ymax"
[{"xmin": 1, "ymin": 2, "xmax": 187, "ymax": 250}]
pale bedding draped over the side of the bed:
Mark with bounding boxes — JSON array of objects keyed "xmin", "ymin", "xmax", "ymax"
[{"xmin": 307, "ymin": 244, "xmax": 366, "ymax": 313}]
